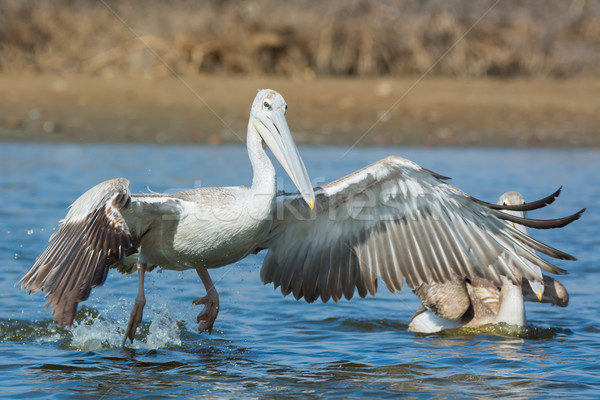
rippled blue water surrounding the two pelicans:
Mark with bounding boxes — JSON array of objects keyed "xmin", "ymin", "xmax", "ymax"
[{"xmin": 0, "ymin": 143, "xmax": 600, "ymax": 399}]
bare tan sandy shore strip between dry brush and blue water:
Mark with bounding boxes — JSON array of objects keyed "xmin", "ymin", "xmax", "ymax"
[{"xmin": 0, "ymin": 75, "xmax": 600, "ymax": 147}]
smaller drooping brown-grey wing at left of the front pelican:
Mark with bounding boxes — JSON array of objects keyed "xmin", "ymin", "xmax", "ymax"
[{"xmin": 17, "ymin": 178, "xmax": 136, "ymax": 326}]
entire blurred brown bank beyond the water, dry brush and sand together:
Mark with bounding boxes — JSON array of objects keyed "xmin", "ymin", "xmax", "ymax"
[{"xmin": 0, "ymin": 0, "xmax": 600, "ymax": 147}]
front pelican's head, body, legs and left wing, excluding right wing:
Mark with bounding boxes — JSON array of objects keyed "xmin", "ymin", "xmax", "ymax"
[{"xmin": 21, "ymin": 90, "xmax": 315, "ymax": 343}]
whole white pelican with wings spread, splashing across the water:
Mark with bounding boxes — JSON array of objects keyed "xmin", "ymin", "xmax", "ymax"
[{"xmin": 20, "ymin": 90, "xmax": 583, "ymax": 343}]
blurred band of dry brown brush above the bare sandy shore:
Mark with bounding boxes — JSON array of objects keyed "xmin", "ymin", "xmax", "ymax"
[{"xmin": 0, "ymin": 0, "xmax": 600, "ymax": 78}]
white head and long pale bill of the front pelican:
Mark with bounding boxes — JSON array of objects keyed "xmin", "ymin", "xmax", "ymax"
[{"xmin": 250, "ymin": 89, "xmax": 315, "ymax": 210}]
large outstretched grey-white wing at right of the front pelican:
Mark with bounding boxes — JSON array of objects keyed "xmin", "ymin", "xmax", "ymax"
[{"xmin": 260, "ymin": 157, "xmax": 583, "ymax": 302}]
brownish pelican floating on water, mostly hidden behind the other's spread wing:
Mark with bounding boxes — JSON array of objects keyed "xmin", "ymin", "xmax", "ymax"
[{"xmin": 408, "ymin": 192, "xmax": 569, "ymax": 333}]
